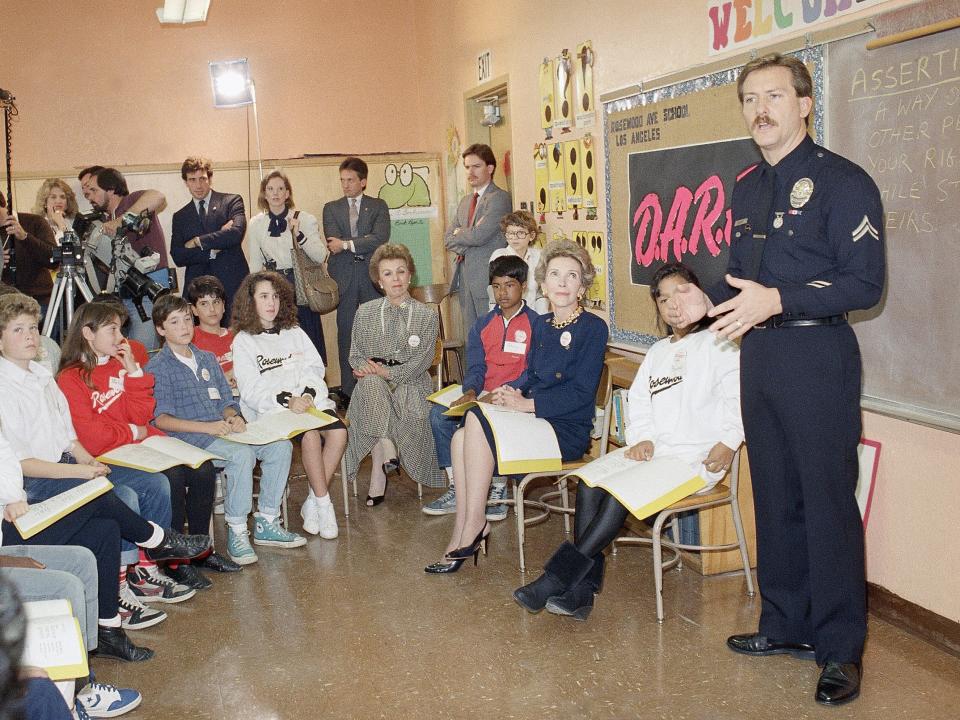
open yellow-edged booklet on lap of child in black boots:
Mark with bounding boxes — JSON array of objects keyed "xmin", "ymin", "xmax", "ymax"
[{"xmin": 570, "ymin": 448, "xmax": 707, "ymax": 520}]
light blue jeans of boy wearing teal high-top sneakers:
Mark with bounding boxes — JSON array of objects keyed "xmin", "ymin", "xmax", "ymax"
[{"xmin": 206, "ymin": 438, "xmax": 293, "ymax": 525}]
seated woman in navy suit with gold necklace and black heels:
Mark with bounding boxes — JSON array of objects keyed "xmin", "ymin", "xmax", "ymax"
[{"xmin": 424, "ymin": 240, "xmax": 608, "ymax": 573}]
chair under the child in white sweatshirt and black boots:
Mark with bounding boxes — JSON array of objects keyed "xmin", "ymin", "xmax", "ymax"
[{"xmin": 612, "ymin": 445, "xmax": 755, "ymax": 623}]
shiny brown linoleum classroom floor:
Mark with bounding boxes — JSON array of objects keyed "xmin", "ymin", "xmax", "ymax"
[{"xmin": 93, "ymin": 471, "xmax": 960, "ymax": 720}]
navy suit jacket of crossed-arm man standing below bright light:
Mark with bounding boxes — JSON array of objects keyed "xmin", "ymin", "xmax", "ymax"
[{"xmin": 170, "ymin": 190, "xmax": 250, "ymax": 300}]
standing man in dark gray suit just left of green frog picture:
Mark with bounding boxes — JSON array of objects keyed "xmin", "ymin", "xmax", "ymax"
[{"xmin": 323, "ymin": 157, "xmax": 390, "ymax": 398}]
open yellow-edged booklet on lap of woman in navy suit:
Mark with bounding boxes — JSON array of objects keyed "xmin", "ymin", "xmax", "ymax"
[{"xmin": 479, "ymin": 403, "xmax": 563, "ymax": 475}]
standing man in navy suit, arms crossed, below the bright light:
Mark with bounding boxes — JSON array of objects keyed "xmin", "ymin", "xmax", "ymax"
[{"xmin": 170, "ymin": 157, "xmax": 250, "ymax": 323}]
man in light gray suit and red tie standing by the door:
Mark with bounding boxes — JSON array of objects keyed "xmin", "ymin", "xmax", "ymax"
[{"xmin": 443, "ymin": 144, "xmax": 513, "ymax": 335}]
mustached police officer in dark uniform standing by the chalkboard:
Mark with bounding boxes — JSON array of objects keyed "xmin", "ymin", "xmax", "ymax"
[{"xmin": 670, "ymin": 55, "xmax": 884, "ymax": 705}]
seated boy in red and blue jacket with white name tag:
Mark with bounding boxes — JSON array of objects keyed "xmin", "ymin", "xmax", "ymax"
[{"xmin": 423, "ymin": 255, "xmax": 538, "ymax": 520}]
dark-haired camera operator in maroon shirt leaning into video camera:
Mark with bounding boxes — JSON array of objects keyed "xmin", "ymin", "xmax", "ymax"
[{"xmin": 81, "ymin": 168, "xmax": 170, "ymax": 350}]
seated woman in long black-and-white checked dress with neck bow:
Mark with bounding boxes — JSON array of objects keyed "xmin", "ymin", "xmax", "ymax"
[{"xmin": 346, "ymin": 243, "xmax": 447, "ymax": 507}]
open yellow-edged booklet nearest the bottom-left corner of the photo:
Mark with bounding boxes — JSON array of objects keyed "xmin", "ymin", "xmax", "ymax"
[{"xmin": 21, "ymin": 600, "xmax": 90, "ymax": 681}]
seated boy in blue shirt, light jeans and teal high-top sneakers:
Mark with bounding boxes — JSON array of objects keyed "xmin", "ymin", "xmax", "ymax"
[{"xmin": 146, "ymin": 295, "xmax": 307, "ymax": 572}]
